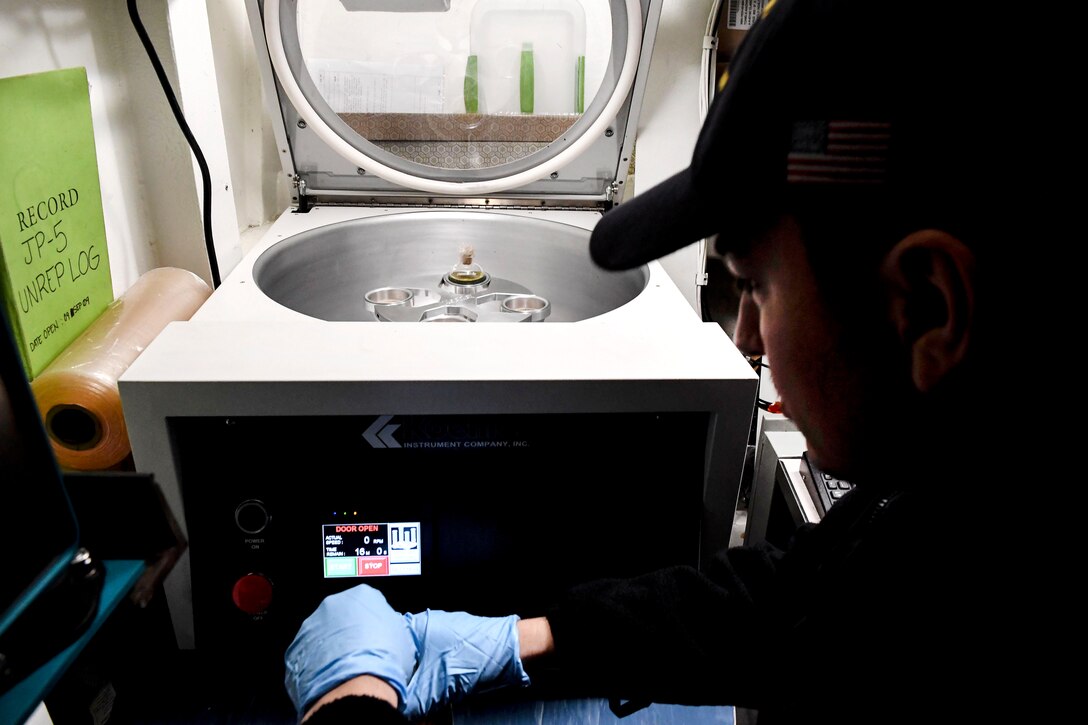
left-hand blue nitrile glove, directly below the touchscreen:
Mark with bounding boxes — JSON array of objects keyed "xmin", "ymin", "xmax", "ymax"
[{"xmin": 284, "ymin": 585, "xmax": 416, "ymax": 716}]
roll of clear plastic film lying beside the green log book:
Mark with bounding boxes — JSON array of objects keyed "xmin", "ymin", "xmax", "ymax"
[{"xmin": 30, "ymin": 267, "xmax": 211, "ymax": 470}]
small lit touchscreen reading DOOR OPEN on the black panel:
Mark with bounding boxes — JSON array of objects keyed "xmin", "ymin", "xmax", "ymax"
[{"xmin": 321, "ymin": 521, "xmax": 421, "ymax": 579}]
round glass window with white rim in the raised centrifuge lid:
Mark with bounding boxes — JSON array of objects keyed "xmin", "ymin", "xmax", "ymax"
[{"xmin": 264, "ymin": 0, "xmax": 642, "ymax": 196}]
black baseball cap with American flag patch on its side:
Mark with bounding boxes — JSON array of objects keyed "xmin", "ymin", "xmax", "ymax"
[{"xmin": 590, "ymin": 0, "xmax": 1013, "ymax": 270}]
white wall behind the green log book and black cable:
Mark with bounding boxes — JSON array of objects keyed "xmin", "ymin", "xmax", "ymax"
[{"xmin": 0, "ymin": 0, "xmax": 287, "ymax": 295}]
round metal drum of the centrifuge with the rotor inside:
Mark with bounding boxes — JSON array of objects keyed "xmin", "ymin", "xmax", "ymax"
[{"xmin": 254, "ymin": 211, "xmax": 648, "ymax": 322}]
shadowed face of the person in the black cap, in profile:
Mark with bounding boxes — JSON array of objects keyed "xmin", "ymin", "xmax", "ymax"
[{"xmin": 726, "ymin": 217, "xmax": 896, "ymax": 480}]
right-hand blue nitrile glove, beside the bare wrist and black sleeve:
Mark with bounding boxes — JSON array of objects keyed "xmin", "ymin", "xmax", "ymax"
[{"xmin": 405, "ymin": 610, "xmax": 529, "ymax": 717}]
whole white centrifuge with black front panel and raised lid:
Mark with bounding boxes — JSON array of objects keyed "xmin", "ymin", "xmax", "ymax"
[{"xmin": 120, "ymin": 0, "xmax": 757, "ymax": 659}]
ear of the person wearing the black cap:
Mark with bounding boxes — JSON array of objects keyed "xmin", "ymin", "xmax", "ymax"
[{"xmin": 883, "ymin": 230, "xmax": 975, "ymax": 392}]
